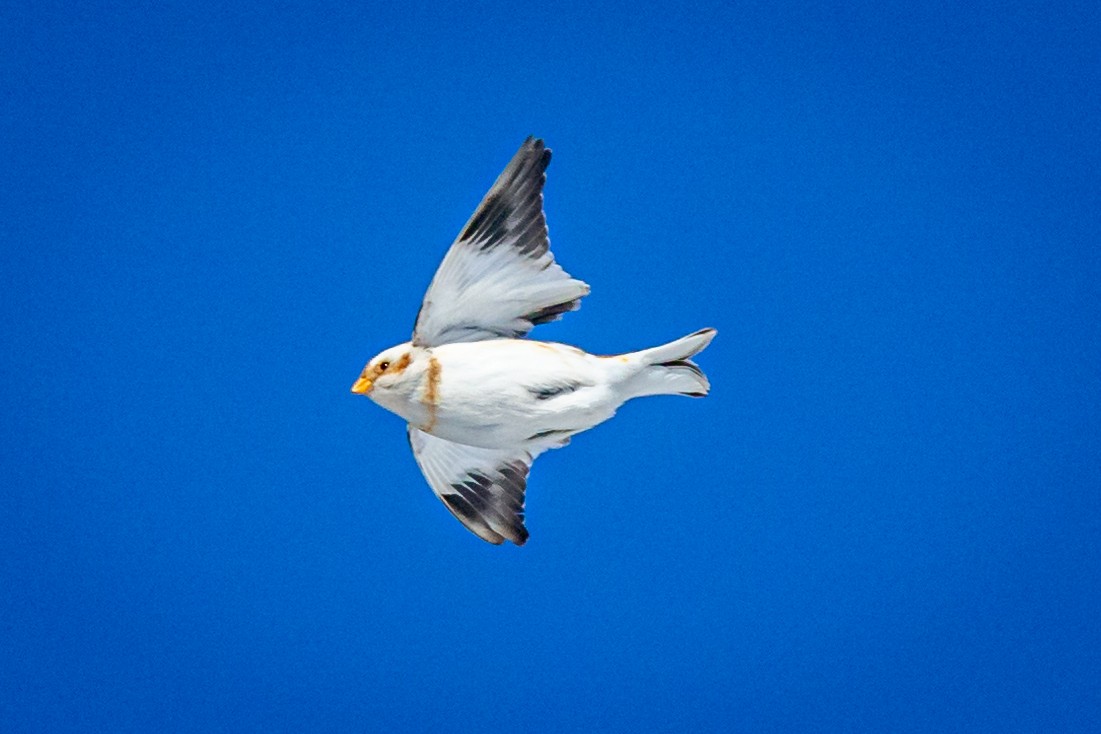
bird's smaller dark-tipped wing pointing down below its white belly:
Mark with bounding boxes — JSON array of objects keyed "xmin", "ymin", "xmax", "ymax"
[{"xmin": 408, "ymin": 426, "xmax": 535, "ymax": 546}]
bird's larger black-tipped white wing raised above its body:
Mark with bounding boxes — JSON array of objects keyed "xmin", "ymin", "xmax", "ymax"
[{"xmin": 413, "ymin": 138, "xmax": 589, "ymax": 347}]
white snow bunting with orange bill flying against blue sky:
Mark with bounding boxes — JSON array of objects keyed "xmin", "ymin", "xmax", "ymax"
[{"xmin": 351, "ymin": 138, "xmax": 716, "ymax": 546}]
